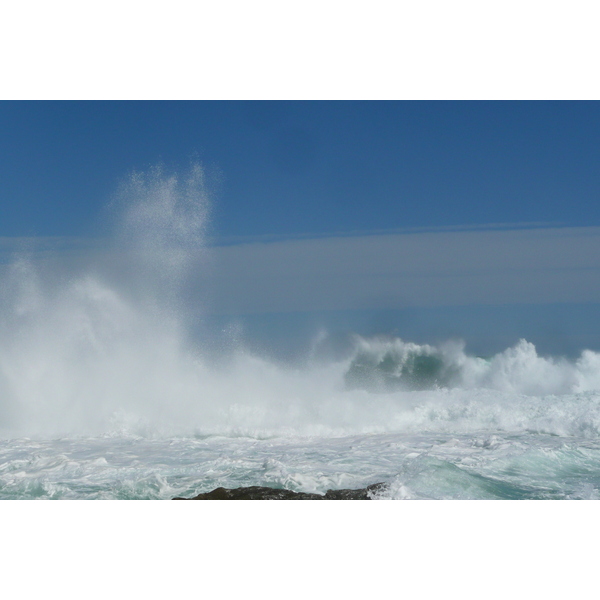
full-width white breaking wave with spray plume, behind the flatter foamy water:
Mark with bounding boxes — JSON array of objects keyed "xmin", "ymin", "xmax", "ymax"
[{"xmin": 0, "ymin": 166, "xmax": 600, "ymax": 437}]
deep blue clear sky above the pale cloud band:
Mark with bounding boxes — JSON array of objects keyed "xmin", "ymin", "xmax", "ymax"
[{"xmin": 0, "ymin": 101, "xmax": 600, "ymax": 236}]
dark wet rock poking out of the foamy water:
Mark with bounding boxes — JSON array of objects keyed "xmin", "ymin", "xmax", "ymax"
[{"xmin": 173, "ymin": 483, "xmax": 386, "ymax": 500}]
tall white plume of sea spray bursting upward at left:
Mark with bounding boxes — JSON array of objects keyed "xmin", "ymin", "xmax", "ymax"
[{"xmin": 0, "ymin": 166, "xmax": 209, "ymax": 435}]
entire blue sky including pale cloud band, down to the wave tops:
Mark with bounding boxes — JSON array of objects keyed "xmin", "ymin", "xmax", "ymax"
[{"xmin": 0, "ymin": 101, "xmax": 600, "ymax": 353}]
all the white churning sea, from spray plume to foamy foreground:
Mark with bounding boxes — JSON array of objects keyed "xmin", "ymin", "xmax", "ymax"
[{"xmin": 0, "ymin": 165, "xmax": 600, "ymax": 499}]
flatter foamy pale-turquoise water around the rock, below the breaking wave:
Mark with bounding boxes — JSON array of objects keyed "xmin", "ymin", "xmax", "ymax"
[{"xmin": 0, "ymin": 432, "xmax": 600, "ymax": 500}]
